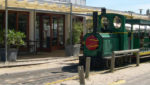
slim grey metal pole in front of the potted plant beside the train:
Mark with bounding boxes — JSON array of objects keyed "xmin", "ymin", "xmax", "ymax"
[{"xmin": 70, "ymin": 3, "xmax": 73, "ymax": 56}]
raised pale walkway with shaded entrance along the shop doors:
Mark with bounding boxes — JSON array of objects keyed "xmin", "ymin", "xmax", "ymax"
[{"xmin": 0, "ymin": 50, "xmax": 82, "ymax": 68}]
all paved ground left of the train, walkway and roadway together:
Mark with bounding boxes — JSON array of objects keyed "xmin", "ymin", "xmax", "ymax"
[{"xmin": 0, "ymin": 53, "xmax": 79, "ymax": 85}]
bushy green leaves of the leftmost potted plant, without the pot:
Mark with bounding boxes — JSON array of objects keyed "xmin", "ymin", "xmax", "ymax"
[{"xmin": 0, "ymin": 30, "xmax": 26, "ymax": 47}]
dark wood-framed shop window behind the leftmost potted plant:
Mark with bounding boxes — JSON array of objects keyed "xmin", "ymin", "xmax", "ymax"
[{"xmin": 0, "ymin": 10, "xmax": 30, "ymax": 50}]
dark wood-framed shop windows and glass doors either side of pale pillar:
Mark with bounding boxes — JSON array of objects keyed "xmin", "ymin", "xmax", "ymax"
[{"xmin": 0, "ymin": 10, "xmax": 65, "ymax": 52}]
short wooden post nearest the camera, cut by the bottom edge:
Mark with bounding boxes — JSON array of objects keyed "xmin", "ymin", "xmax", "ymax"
[{"xmin": 78, "ymin": 66, "xmax": 85, "ymax": 85}]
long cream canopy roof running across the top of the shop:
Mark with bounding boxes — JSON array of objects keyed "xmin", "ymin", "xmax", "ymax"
[{"xmin": 0, "ymin": 0, "xmax": 149, "ymax": 19}]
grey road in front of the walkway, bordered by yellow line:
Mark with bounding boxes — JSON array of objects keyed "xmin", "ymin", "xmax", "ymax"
[{"xmin": 0, "ymin": 65, "xmax": 77, "ymax": 85}]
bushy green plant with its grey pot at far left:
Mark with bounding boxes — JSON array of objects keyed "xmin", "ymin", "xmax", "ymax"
[{"xmin": 0, "ymin": 30, "xmax": 25, "ymax": 61}]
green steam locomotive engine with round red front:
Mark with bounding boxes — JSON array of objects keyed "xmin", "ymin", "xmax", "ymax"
[{"xmin": 80, "ymin": 9, "xmax": 128, "ymax": 67}]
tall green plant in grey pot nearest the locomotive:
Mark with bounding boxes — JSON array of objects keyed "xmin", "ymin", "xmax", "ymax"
[{"xmin": 65, "ymin": 22, "xmax": 83, "ymax": 56}]
